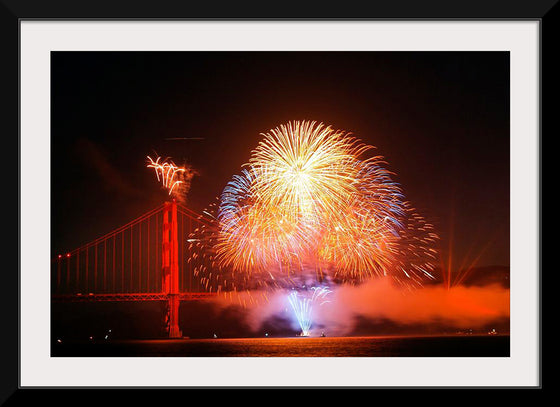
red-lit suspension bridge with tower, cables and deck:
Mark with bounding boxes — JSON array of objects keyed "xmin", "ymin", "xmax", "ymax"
[{"xmin": 51, "ymin": 200, "xmax": 216, "ymax": 338}]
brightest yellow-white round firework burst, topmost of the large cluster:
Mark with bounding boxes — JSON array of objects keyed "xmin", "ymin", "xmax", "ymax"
[{"xmin": 249, "ymin": 121, "xmax": 372, "ymax": 220}]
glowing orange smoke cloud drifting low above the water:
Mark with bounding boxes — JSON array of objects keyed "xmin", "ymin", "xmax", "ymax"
[{"xmin": 208, "ymin": 278, "xmax": 510, "ymax": 335}]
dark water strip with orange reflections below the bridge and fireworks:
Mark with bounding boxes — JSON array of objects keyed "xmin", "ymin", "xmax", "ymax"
[{"xmin": 52, "ymin": 335, "xmax": 510, "ymax": 357}]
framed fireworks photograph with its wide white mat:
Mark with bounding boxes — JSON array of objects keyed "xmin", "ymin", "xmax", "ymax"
[{"xmin": 4, "ymin": 1, "xmax": 557, "ymax": 400}]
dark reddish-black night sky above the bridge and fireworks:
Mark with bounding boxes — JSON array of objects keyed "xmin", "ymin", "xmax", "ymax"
[{"xmin": 51, "ymin": 52, "xmax": 510, "ymax": 266}]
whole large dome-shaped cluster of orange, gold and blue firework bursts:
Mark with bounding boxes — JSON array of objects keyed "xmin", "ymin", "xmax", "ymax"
[{"xmin": 210, "ymin": 121, "xmax": 437, "ymax": 284}]
